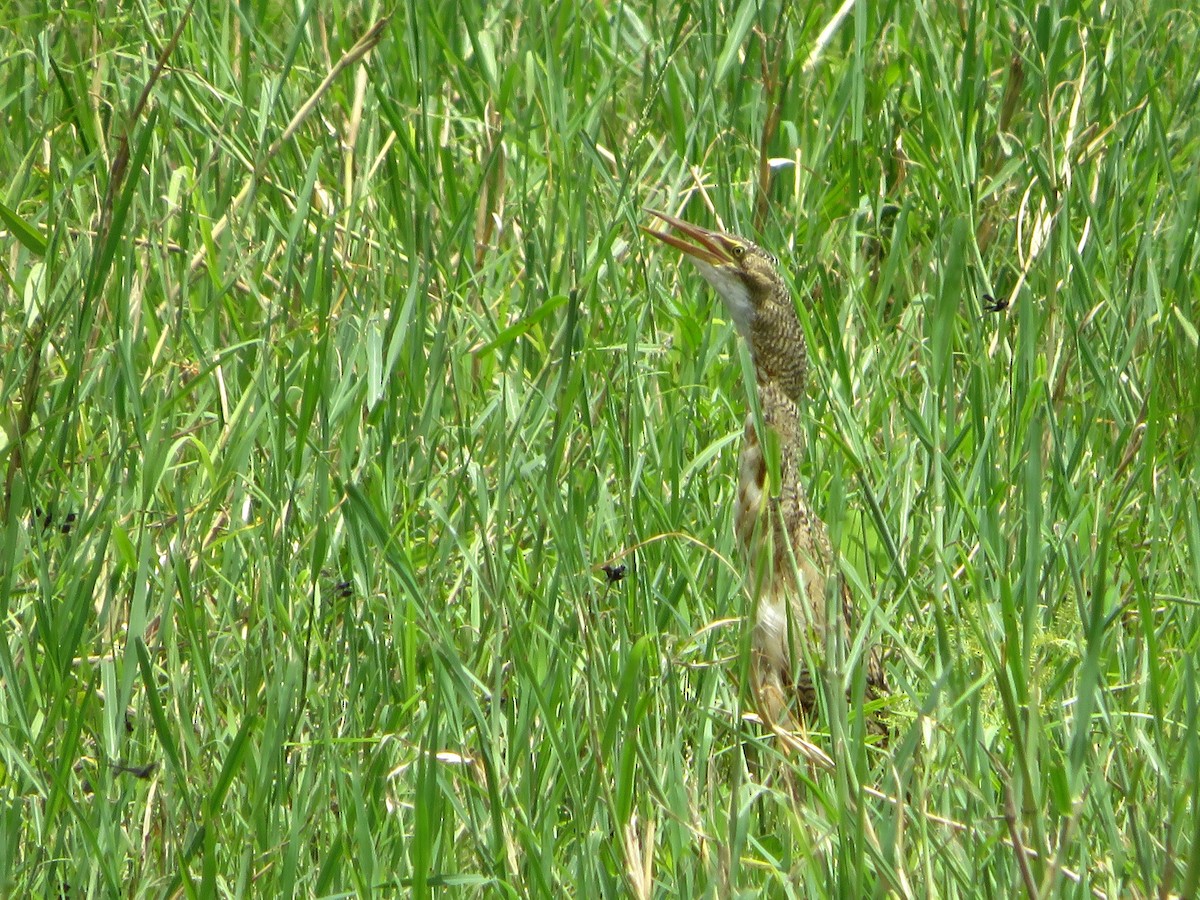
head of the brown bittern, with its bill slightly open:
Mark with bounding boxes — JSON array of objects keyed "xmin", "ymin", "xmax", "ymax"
[{"xmin": 642, "ymin": 210, "xmax": 790, "ymax": 344}]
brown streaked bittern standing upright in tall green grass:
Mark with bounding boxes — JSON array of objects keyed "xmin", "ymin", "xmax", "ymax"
[{"xmin": 642, "ymin": 210, "xmax": 887, "ymax": 734}]
